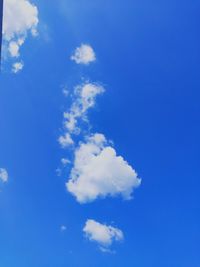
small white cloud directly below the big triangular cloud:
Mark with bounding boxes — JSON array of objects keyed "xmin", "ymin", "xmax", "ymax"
[{"xmin": 83, "ymin": 220, "xmax": 124, "ymax": 252}]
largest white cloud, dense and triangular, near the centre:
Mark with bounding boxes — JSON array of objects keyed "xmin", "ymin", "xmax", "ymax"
[{"xmin": 66, "ymin": 134, "xmax": 141, "ymax": 203}]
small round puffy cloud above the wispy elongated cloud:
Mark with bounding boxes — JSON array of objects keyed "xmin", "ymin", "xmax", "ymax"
[{"xmin": 71, "ymin": 44, "xmax": 96, "ymax": 65}]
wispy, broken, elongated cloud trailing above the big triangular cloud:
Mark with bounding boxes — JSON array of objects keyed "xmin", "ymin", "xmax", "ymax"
[{"xmin": 59, "ymin": 83, "xmax": 104, "ymax": 147}]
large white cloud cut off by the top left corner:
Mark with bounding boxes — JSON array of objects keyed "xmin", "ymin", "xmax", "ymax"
[{"xmin": 3, "ymin": 0, "xmax": 39, "ymax": 73}]
